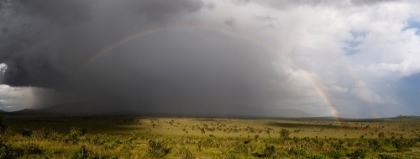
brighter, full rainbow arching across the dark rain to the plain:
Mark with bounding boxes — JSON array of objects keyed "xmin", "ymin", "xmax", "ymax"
[{"xmin": 69, "ymin": 25, "xmax": 340, "ymax": 122}]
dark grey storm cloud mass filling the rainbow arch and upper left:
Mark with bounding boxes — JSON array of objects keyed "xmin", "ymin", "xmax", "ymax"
[{"xmin": 0, "ymin": 0, "xmax": 292, "ymax": 115}]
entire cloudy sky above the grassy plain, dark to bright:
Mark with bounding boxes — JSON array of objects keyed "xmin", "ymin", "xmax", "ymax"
[{"xmin": 0, "ymin": 0, "xmax": 420, "ymax": 118}]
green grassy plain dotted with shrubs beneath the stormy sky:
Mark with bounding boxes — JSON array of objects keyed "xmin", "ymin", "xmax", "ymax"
[{"xmin": 0, "ymin": 115, "xmax": 420, "ymax": 159}]
